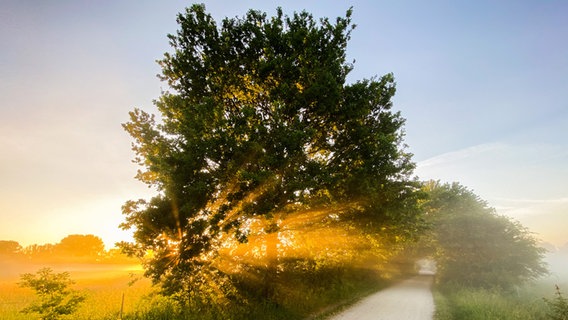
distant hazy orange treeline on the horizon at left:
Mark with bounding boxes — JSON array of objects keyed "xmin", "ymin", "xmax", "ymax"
[{"xmin": 0, "ymin": 234, "xmax": 137, "ymax": 263}]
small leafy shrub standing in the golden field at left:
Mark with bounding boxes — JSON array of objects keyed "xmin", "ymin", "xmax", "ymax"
[{"xmin": 19, "ymin": 268, "xmax": 85, "ymax": 320}]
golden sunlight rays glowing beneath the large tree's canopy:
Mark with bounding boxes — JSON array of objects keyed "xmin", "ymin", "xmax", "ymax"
[{"xmin": 214, "ymin": 203, "xmax": 398, "ymax": 281}]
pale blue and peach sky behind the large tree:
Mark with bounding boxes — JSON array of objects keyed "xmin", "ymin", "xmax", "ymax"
[{"xmin": 0, "ymin": 0, "xmax": 568, "ymax": 246}]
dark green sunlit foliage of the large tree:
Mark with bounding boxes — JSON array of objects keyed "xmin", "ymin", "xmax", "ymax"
[{"xmin": 121, "ymin": 5, "xmax": 419, "ymax": 296}]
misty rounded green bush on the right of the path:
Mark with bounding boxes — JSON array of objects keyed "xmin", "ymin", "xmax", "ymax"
[{"xmin": 423, "ymin": 182, "xmax": 547, "ymax": 289}]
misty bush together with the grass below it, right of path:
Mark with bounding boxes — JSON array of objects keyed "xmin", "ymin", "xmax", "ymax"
[{"xmin": 418, "ymin": 181, "xmax": 568, "ymax": 320}]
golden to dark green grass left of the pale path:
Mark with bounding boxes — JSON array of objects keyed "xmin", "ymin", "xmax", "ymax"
[{"xmin": 0, "ymin": 266, "xmax": 394, "ymax": 320}]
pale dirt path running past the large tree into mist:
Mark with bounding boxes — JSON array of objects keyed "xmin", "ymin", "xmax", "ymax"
[{"xmin": 329, "ymin": 275, "xmax": 434, "ymax": 320}]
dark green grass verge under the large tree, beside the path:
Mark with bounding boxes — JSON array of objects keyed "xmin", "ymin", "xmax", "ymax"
[{"xmin": 125, "ymin": 270, "xmax": 387, "ymax": 320}]
